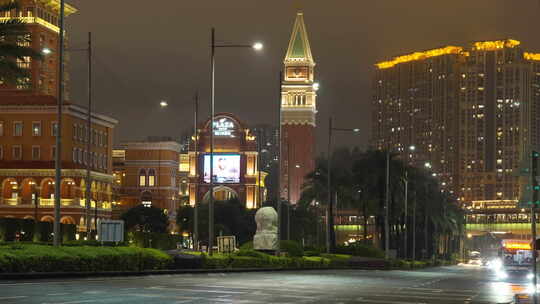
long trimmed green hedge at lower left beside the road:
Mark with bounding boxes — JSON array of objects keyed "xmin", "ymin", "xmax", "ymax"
[{"xmin": 0, "ymin": 244, "xmax": 172, "ymax": 273}]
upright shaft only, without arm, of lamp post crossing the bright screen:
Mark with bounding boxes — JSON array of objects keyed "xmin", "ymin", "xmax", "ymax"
[{"xmin": 208, "ymin": 28, "xmax": 216, "ymax": 255}]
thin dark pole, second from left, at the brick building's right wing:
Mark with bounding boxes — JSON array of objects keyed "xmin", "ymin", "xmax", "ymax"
[{"xmin": 84, "ymin": 32, "xmax": 92, "ymax": 239}]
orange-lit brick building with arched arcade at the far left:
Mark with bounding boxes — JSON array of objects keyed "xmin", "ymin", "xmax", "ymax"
[{"xmin": 0, "ymin": 0, "xmax": 118, "ymax": 230}]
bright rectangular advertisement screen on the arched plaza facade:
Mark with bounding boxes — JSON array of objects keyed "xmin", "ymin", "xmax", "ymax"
[{"xmin": 204, "ymin": 154, "xmax": 240, "ymax": 184}]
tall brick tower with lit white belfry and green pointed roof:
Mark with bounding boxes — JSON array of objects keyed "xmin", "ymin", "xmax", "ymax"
[{"xmin": 281, "ymin": 12, "xmax": 317, "ymax": 204}]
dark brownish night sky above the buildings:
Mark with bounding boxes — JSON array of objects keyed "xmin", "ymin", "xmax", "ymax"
[{"xmin": 67, "ymin": 0, "xmax": 540, "ymax": 152}]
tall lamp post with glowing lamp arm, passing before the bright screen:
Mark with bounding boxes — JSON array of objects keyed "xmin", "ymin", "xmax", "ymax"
[{"xmin": 208, "ymin": 28, "xmax": 263, "ymax": 255}]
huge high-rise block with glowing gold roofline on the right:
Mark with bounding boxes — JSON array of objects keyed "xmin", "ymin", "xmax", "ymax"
[{"xmin": 372, "ymin": 39, "xmax": 540, "ymax": 238}]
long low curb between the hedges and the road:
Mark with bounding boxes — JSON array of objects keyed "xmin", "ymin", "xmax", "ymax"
[{"xmin": 0, "ymin": 267, "xmax": 386, "ymax": 280}]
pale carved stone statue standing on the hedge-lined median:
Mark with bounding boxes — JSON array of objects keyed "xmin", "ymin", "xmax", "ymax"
[{"xmin": 253, "ymin": 207, "xmax": 278, "ymax": 250}]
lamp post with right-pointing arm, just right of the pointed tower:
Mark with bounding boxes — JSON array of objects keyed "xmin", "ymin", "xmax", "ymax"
[{"xmin": 324, "ymin": 117, "xmax": 360, "ymax": 253}]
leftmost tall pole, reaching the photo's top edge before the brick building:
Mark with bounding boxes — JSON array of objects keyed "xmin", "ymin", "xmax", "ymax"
[{"xmin": 53, "ymin": 0, "xmax": 65, "ymax": 246}]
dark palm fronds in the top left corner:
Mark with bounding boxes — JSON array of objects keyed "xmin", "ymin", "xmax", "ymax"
[{"xmin": 0, "ymin": 1, "xmax": 41, "ymax": 84}]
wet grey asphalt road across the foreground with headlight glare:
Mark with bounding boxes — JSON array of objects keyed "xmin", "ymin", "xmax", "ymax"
[{"xmin": 0, "ymin": 266, "xmax": 526, "ymax": 304}]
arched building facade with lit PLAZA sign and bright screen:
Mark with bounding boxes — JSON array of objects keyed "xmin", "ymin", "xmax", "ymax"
[{"xmin": 179, "ymin": 113, "xmax": 267, "ymax": 208}]
